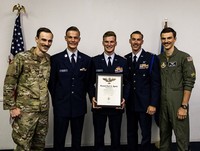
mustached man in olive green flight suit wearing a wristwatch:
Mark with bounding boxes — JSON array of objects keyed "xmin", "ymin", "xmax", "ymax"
[{"xmin": 159, "ymin": 27, "xmax": 196, "ymax": 151}]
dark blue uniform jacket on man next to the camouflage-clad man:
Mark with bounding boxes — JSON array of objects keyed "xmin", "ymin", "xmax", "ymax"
[{"xmin": 49, "ymin": 50, "xmax": 91, "ymax": 117}]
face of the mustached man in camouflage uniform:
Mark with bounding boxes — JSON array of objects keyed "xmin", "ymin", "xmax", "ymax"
[{"xmin": 35, "ymin": 32, "xmax": 53, "ymax": 53}]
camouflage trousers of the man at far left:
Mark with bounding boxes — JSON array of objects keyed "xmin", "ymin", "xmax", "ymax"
[{"xmin": 12, "ymin": 111, "xmax": 49, "ymax": 151}]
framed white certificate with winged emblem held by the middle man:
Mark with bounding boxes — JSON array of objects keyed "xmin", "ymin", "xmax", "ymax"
[{"xmin": 96, "ymin": 74, "xmax": 123, "ymax": 107}]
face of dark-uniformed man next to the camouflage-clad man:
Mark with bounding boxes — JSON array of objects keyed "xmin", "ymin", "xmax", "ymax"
[{"xmin": 65, "ymin": 31, "xmax": 81, "ymax": 51}]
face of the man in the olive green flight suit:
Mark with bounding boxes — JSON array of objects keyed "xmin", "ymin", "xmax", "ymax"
[{"xmin": 161, "ymin": 32, "xmax": 176, "ymax": 51}]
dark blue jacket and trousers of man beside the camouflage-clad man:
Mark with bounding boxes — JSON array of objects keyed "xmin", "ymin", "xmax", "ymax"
[{"xmin": 49, "ymin": 50, "xmax": 91, "ymax": 151}]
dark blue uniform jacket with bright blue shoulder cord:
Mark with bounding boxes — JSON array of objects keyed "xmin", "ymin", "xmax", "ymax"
[{"xmin": 125, "ymin": 50, "xmax": 161, "ymax": 112}]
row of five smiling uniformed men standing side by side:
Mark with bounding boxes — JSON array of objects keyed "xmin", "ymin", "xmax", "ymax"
[{"xmin": 4, "ymin": 26, "xmax": 195, "ymax": 151}]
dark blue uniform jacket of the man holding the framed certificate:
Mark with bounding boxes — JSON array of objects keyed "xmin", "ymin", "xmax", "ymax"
[{"xmin": 89, "ymin": 54, "xmax": 130, "ymax": 113}]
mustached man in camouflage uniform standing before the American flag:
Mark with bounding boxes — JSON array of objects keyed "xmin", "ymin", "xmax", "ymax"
[{"xmin": 3, "ymin": 28, "xmax": 53, "ymax": 151}]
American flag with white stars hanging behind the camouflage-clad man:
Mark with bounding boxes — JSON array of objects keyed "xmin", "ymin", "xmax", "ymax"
[{"xmin": 9, "ymin": 14, "xmax": 24, "ymax": 61}]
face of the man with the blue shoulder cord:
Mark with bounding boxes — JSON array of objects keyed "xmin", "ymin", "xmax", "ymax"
[{"xmin": 129, "ymin": 34, "xmax": 143, "ymax": 53}]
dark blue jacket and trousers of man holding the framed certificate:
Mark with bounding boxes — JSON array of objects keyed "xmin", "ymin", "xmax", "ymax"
[{"xmin": 89, "ymin": 54, "xmax": 129, "ymax": 151}]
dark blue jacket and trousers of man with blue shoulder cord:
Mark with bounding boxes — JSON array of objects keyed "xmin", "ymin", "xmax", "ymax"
[{"xmin": 125, "ymin": 49, "xmax": 160, "ymax": 151}]
